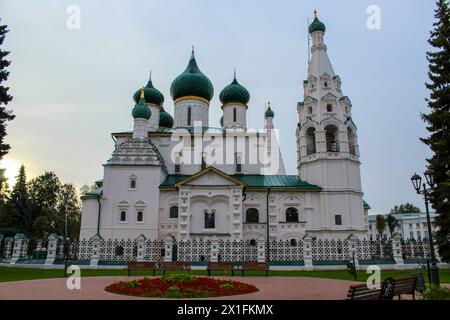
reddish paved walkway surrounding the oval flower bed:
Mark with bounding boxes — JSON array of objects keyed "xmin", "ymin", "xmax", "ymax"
[{"xmin": 0, "ymin": 276, "xmax": 355, "ymax": 300}]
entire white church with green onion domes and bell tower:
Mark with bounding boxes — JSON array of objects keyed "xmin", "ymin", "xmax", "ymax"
[{"xmin": 80, "ymin": 15, "xmax": 369, "ymax": 241}]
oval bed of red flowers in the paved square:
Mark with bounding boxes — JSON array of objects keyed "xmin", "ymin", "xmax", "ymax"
[{"xmin": 105, "ymin": 274, "xmax": 258, "ymax": 298}]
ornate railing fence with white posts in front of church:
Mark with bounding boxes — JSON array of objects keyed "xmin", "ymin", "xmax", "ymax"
[{"xmin": 0, "ymin": 235, "xmax": 438, "ymax": 266}]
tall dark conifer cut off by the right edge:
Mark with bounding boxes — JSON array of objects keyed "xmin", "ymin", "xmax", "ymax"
[{"xmin": 421, "ymin": 0, "xmax": 450, "ymax": 261}]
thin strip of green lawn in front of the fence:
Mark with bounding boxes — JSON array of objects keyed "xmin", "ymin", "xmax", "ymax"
[{"xmin": 0, "ymin": 267, "xmax": 450, "ymax": 283}]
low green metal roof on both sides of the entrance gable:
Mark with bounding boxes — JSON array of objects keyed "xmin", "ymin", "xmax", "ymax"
[{"xmin": 160, "ymin": 174, "xmax": 321, "ymax": 190}]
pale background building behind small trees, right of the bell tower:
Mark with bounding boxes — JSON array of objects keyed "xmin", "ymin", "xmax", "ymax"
[{"xmin": 369, "ymin": 212, "xmax": 437, "ymax": 240}]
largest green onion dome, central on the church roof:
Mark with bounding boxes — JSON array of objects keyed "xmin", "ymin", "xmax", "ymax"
[{"xmin": 170, "ymin": 48, "xmax": 214, "ymax": 101}]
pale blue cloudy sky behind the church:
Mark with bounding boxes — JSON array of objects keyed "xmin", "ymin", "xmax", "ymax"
[{"xmin": 0, "ymin": 0, "xmax": 435, "ymax": 213}]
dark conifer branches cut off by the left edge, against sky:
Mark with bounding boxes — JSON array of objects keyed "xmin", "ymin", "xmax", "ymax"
[{"xmin": 0, "ymin": 19, "xmax": 15, "ymax": 160}]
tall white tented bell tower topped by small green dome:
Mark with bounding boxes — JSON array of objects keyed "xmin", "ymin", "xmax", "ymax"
[{"xmin": 296, "ymin": 11, "xmax": 364, "ymax": 232}]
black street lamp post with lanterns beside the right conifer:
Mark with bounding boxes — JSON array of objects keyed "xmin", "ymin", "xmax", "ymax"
[{"xmin": 411, "ymin": 169, "xmax": 439, "ymax": 285}]
